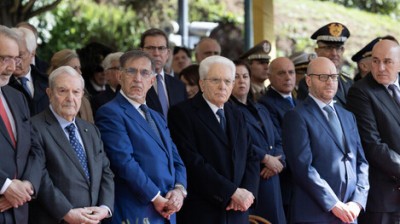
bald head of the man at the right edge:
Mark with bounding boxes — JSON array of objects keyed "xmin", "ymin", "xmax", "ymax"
[{"xmin": 371, "ymin": 40, "xmax": 400, "ymax": 85}]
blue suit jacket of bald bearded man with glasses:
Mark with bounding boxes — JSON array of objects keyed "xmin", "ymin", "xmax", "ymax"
[{"xmin": 282, "ymin": 97, "xmax": 369, "ymax": 223}]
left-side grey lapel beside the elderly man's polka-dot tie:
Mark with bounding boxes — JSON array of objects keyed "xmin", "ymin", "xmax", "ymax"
[{"xmin": 45, "ymin": 108, "xmax": 89, "ymax": 183}]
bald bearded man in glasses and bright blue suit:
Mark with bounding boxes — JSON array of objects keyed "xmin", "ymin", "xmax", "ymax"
[{"xmin": 282, "ymin": 57, "xmax": 369, "ymax": 223}]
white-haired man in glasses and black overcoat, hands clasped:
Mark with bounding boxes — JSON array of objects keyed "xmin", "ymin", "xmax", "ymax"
[{"xmin": 168, "ymin": 56, "xmax": 260, "ymax": 224}]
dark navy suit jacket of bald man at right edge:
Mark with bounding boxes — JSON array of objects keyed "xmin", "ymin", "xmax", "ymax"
[{"xmin": 347, "ymin": 74, "xmax": 400, "ymax": 212}]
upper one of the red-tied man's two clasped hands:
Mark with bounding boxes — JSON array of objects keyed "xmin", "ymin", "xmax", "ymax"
[{"xmin": 3, "ymin": 179, "xmax": 33, "ymax": 208}]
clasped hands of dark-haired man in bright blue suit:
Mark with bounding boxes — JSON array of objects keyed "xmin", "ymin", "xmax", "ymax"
[{"xmin": 153, "ymin": 188, "xmax": 184, "ymax": 219}]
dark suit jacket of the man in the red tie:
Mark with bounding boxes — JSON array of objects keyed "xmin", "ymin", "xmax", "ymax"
[{"xmin": 0, "ymin": 86, "xmax": 40, "ymax": 224}]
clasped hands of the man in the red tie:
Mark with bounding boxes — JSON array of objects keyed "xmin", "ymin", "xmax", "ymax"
[{"xmin": 0, "ymin": 179, "xmax": 33, "ymax": 212}]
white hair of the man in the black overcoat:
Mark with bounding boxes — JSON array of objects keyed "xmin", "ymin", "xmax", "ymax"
[{"xmin": 199, "ymin": 55, "xmax": 236, "ymax": 80}]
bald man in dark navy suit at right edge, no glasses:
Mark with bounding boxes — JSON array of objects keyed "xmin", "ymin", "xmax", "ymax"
[{"xmin": 348, "ymin": 40, "xmax": 400, "ymax": 224}]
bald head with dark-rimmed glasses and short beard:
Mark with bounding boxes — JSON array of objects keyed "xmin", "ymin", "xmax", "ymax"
[{"xmin": 306, "ymin": 57, "xmax": 339, "ymax": 104}]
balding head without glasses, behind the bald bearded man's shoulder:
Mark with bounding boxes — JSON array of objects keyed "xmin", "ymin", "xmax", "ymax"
[{"xmin": 268, "ymin": 57, "xmax": 296, "ymax": 94}]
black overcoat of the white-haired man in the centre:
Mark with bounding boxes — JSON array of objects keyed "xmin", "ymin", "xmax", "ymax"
[{"xmin": 168, "ymin": 93, "xmax": 260, "ymax": 224}]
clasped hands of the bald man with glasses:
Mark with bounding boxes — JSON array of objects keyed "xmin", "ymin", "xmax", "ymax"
[{"xmin": 332, "ymin": 201, "xmax": 361, "ymax": 223}]
